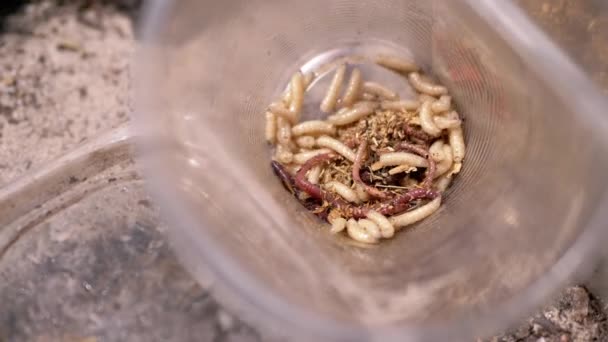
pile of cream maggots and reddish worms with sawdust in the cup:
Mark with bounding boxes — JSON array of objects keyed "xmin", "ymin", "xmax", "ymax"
[{"xmin": 265, "ymin": 55, "xmax": 465, "ymax": 244}]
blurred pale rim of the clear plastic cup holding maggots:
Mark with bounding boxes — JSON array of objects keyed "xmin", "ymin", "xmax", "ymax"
[{"xmin": 134, "ymin": 0, "xmax": 608, "ymax": 341}]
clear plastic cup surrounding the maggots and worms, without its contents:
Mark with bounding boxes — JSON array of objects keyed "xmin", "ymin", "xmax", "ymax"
[{"xmin": 136, "ymin": 0, "xmax": 608, "ymax": 341}]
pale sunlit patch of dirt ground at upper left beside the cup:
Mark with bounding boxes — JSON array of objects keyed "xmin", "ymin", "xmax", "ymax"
[{"xmin": 0, "ymin": 1, "xmax": 134, "ymax": 185}]
